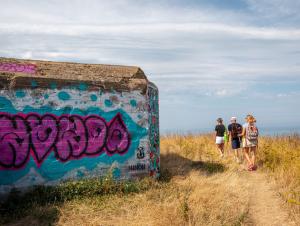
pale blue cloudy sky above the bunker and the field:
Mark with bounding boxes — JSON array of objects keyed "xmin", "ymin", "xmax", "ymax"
[{"xmin": 0, "ymin": 0, "xmax": 300, "ymax": 133}]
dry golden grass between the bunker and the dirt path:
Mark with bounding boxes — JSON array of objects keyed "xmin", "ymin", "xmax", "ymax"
[{"xmin": 58, "ymin": 135, "xmax": 254, "ymax": 225}]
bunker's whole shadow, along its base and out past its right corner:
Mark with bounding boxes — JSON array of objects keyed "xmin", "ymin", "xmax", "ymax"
[{"xmin": 0, "ymin": 153, "xmax": 226, "ymax": 226}]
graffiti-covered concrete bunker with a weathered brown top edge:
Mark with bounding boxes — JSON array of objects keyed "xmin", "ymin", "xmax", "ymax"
[{"xmin": 0, "ymin": 58, "xmax": 160, "ymax": 194}]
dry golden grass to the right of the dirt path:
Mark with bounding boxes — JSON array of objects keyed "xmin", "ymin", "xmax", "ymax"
[{"xmin": 258, "ymin": 135, "xmax": 300, "ymax": 214}]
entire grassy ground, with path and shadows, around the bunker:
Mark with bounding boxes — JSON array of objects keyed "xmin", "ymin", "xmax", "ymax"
[{"xmin": 0, "ymin": 134, "xmax": 300, "ymax": 225}]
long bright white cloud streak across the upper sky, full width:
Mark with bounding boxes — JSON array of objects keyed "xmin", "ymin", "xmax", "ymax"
[{"xmin": 0, "ymin": 22, "xmax": 300, "ymax": 40}]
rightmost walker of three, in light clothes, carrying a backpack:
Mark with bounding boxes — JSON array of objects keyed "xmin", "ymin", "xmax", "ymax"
[{"xmin": 242, "ymin": 115, "xmax": 259, "ymax": 171}]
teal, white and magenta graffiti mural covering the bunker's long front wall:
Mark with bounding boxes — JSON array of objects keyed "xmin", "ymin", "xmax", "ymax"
[{"xmin": 0, "ymin": 84, "xmax": 149, "ymax": 193}]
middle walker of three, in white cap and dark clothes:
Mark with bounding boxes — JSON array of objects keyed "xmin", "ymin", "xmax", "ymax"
[{"xmin": 228, "ymin": 117, "xmax": 243, "ymax": 163}]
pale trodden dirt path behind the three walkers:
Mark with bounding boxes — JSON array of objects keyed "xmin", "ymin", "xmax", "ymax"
[{"xmin": 241, "ymin": 171, "xmax": 296, "ymax": 226}]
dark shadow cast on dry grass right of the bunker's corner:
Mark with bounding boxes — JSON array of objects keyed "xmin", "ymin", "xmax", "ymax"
[{"xmin": 161, "ymin": 153, "xmax": 226, "ymax": 181}]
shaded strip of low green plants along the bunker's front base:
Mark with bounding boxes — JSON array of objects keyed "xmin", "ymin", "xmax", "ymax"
[{"xmin": 0, "ymin": 173, "xmax": 158, "ymax": 226}]
